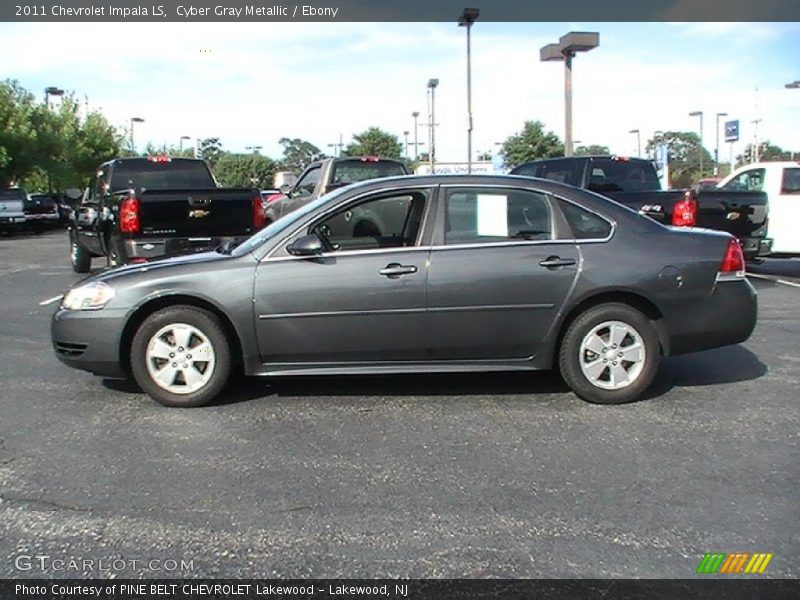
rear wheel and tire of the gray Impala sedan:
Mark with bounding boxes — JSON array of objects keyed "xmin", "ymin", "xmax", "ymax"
[{"xmin": 558, "ymin": 303, "xmax": 661, "ymax": 404}]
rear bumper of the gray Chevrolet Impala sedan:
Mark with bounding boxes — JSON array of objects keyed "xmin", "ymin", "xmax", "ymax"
[{"xmin": 668, "ymin": 279, "xmax": 758, "ymax": 355}]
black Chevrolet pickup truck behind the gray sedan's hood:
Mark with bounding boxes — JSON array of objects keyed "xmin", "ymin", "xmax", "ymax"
[{"xmin": 69, "ymin": 156, "xmax": 264, "ymax": 273}]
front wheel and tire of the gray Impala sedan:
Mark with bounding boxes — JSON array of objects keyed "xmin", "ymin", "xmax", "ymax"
[{"xmin": 131, "ymin": 306, "xmax": 231, "ymax": 408}]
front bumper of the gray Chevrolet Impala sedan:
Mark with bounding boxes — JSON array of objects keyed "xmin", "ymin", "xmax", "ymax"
[{"xmin": 50, "ymin": 308, "xmax": 128, "ymax": 379}]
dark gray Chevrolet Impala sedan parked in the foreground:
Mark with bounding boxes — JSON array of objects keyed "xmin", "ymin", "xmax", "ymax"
[{"xmin": 52, "ymin": 176, "xmax": 756, "ymax": 406}]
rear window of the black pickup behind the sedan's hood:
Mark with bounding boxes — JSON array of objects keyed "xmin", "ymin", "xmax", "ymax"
[{"xmin": 111, "ymin": 159, "xmax": 216, "ymax": 191}]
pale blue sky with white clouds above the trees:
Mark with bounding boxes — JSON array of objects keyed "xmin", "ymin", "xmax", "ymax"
[{"xmin": 0, "ymin": 21, "xmax": 800, "ymax": 161}]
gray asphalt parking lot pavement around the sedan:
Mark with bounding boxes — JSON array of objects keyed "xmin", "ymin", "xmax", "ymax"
[{"xmin": 0, "ymin": 231, "xmax": 800, "ymax": 578}]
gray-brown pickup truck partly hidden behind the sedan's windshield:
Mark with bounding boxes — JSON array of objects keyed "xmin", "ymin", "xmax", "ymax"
[{"xmin": 266, "ymin": 156, "xmax": 409, "ymax": 223}]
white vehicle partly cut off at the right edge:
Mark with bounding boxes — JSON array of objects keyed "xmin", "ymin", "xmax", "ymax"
[{"xmin": 717, "ymin": 162, "xmax": 800, "ymax": 255}]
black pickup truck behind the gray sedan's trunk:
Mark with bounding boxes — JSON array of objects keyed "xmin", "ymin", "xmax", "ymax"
[{"xmin": 511, "ymin": 156, "xmax": 772, "ymax": 259}]
